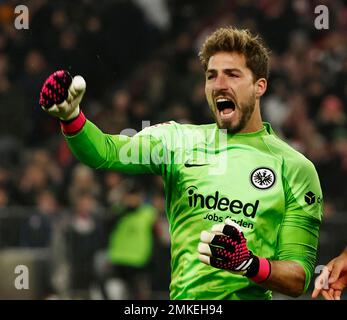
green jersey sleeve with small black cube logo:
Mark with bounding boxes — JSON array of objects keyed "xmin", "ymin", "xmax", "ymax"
[{"xmin": 277, "ymin": 161, "xmax": 323, "ymax": 291}]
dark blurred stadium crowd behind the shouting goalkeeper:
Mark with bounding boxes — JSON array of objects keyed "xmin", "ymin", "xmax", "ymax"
[{"xmin": 0, "ymin": 0, "xmax": 347, "ymax": 299}]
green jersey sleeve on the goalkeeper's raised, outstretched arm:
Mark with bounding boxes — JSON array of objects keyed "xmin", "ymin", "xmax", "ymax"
[{"xmin": 65, "ymin": 120, "xmax": 166, "ymax": 175}]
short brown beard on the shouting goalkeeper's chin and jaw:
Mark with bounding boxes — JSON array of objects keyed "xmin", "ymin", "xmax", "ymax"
[{"xmin": 213, "ymin": 95, "xmax": 255, "ymax": 133}]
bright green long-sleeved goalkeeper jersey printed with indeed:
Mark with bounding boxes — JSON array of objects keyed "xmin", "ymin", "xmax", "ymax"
[{"xmin": 66, "ymin": 120, "xmax": 322, "ymax": 299}]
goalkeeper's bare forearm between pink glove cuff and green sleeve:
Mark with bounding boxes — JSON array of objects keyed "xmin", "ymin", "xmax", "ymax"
[{"xmin": 260, "ymin": 261, "xmax": 305, "ymax": 297}]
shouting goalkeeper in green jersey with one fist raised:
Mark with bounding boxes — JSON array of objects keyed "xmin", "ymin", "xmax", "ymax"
[{"xmin": 40, "ymin": 27, "xmax": 322, "ymax": 299}]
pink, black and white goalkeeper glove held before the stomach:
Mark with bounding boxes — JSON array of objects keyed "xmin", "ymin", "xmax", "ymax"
[{"xmin": 198, "ymin": 219, "xmax": 271, "ymax": 283}]
